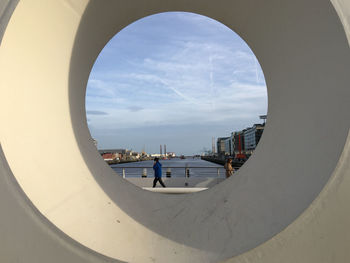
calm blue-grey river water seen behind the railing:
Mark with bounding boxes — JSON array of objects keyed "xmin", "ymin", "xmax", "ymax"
[{"xmin": 111, "ymin": 158, "xmax": 225, "ymax": 178}]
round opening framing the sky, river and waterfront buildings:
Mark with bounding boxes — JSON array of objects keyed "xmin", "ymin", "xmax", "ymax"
[{"xmin": 86, "ymin": 12, "xmax": 267, "ymax": 192}]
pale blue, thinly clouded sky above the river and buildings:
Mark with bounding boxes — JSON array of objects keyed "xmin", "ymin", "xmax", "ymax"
[{"xmin": 86, "ymin": 12, "xmax": 267, "ymax": 155}]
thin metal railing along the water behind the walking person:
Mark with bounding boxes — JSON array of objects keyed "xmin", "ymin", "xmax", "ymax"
[{"xmin": 111, "ymin": 165, "xmax": 230, "ymax": 178}]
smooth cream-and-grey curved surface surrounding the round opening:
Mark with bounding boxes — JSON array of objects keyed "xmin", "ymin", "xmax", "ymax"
[{"xmin": 0, "ymin": 0, "xmax": 350, "ymax": 263}]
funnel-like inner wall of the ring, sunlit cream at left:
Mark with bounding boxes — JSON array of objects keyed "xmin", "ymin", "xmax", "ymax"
[{"xmin": 1, "ymin": 1, "xmax": 349, "ymax": 262}]
